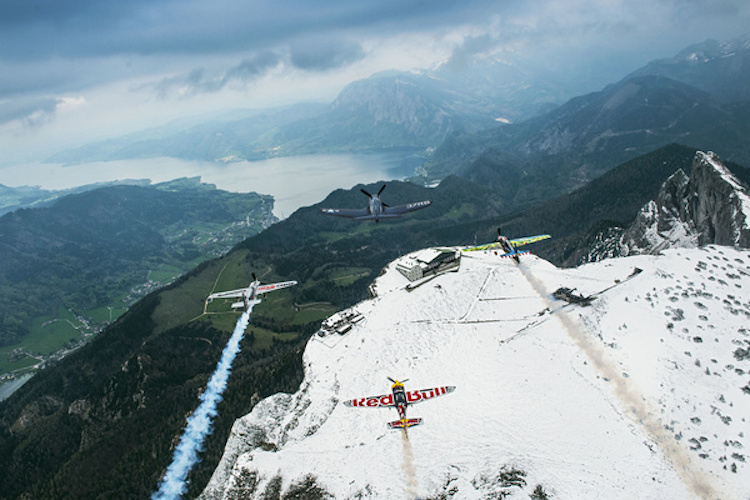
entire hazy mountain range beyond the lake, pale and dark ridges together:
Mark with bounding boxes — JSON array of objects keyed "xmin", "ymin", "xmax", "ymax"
[{"xmin": 49, "ymin": 35, "xmax": 750, "ymax": 209}]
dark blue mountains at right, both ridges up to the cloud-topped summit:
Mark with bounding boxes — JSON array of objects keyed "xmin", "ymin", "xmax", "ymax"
[{"xmin": 421, "ymin": 36, "xmax": 750, "ymax": 190}]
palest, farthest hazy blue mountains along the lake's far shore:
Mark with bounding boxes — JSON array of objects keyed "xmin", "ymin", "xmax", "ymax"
[{"xmin": 42, "ymin": 48, "xmax": 604, "ymax": 164}]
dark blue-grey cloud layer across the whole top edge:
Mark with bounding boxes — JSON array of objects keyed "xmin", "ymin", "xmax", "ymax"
[{"xmin": 0, "ymin": 0, "xmax": 748, "ymax": 104}]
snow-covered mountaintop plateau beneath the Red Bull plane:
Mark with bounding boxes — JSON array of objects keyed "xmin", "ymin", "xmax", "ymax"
[{"xmin": 202, "ymin": 245, "xmax": 750, "ymax": 499}]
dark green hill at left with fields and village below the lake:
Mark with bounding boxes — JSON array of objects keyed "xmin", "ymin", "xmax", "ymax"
[{"xmin": 0, "ymin": 179, "xmax": 276, "ymax": 354}]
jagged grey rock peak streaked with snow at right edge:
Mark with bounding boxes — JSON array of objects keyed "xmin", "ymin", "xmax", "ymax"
[{"xmin": 620, "ymin": 151, "xmax": 750, "ymax": 255}]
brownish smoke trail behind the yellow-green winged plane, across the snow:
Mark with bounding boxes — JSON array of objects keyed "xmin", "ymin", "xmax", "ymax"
[{"xmin": 519, "ymin": 265, "xmax": 721, "ymax": 500}]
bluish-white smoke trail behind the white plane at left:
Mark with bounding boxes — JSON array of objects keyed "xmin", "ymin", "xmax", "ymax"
[{"xmin": 151, "ymin": 306, "xmax": 252, "ymax": 500}]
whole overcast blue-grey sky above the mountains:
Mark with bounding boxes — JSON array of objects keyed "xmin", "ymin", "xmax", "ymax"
[{"xmin": 0, "ymin": 0, "xmax": 750, "ymax": 163}]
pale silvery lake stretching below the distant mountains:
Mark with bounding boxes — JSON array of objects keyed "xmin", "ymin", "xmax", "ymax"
[{"xmin": 0, "ymin": 149, "xmax": 421, "ymax": 219}]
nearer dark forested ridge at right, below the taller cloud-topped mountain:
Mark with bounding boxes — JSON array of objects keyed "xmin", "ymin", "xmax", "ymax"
[{"xmin": 422, "ymin": 75, "xmax": 750, "ymax": 190}]
